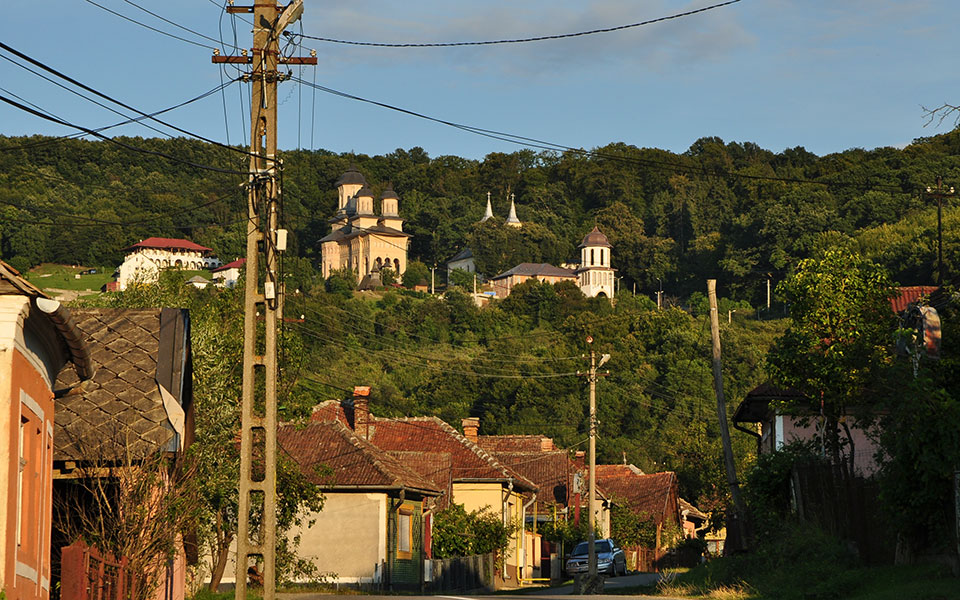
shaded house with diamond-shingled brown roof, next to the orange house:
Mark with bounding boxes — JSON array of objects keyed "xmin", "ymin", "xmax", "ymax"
[{"xmin": 53, "ymin": 308, "xmax": 197, "ymax": 600}]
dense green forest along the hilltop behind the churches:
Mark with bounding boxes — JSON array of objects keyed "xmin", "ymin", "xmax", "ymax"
[{"xmin": 0, "ymin": 132, "xmax": 960, "ymax": 304}]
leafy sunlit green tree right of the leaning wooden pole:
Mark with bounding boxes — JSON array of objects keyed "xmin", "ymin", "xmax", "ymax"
[{"xmin": 768, "ymin": 249, "xmax": 895, "ymax": 466}]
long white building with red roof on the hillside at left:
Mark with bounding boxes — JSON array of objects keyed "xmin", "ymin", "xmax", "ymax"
[{"xmin": 117, "ymin": 237, "xmax": 220, "ymax": 290}]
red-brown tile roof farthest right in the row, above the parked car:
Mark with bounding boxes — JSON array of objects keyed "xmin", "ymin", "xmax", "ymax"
[{"xmin": 597, "ymin": 465, "xmax": 679, "ymax": 524}]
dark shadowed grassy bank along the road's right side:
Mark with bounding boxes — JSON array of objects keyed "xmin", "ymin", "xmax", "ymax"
[{"xmin": 655, "ymin": 525, "xmax": 960, "ymax": 600}]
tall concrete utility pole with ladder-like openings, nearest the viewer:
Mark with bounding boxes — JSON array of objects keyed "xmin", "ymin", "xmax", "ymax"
[{"xmin": 212, "ymin": 0, "xmax": 317, "ymax": 600}]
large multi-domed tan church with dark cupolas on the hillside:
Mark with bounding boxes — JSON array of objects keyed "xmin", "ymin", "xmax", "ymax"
[{"xmin": 320, "ymin": 167, "xmax": 413, "ymax": 283}]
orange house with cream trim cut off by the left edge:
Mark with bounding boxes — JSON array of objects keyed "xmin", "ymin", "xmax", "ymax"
[{"xmin": 0, "ymin": 261, "xmax": 94, "ymax": 600}]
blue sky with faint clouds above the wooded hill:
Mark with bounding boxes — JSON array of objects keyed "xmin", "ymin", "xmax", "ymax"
[{"xmin": 0, "ymin": 0, "xmax": 960, "ymax": 158}]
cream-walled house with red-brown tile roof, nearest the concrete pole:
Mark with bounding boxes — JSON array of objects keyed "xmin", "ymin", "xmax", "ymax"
[{"xmin": 277, "ymin": 414, "xmax": 442, "ymax": 590}]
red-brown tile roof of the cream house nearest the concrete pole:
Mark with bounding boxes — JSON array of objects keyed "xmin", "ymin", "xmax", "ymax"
[{"xmin": 277, "ymin": 422, "xmax": 441, "ymax": 496}]
